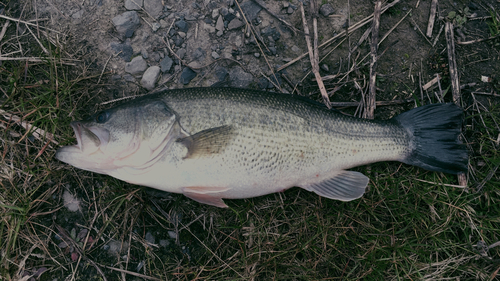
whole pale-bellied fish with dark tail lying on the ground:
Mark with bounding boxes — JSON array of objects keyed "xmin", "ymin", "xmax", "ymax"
[{"xmin": 55, "ymin": 88, "xmax": 468, "ymax": 208}]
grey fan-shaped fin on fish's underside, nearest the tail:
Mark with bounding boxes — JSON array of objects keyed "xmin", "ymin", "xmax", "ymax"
[{"xmin": 301, "ymin": 171, "xmax": 369, "ymax": 201}]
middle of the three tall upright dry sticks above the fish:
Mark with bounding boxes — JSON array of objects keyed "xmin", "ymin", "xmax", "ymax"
[{"xmin": 363, "ymin": 1, "xmax": 382, "ymax": 119}]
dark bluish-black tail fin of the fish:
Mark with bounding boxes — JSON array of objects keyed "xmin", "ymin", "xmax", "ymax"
[{"xmin": 394, "ymin": 103, "xmax": 468, "ymax": 174}]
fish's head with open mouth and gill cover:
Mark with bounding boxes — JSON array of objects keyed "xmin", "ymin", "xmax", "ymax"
[{"xmin": 55, "ymin": 99, "xmax": 182, "ymax": 174}]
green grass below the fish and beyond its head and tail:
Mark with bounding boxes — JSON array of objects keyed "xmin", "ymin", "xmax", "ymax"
[{"xmin": 0, "ymin": 3, "xmax": 500, "ymax": 280}]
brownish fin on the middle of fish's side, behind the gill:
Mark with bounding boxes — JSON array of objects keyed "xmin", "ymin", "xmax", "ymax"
[{"xmin": 178, "ymin": 125, "xmax": 236, "ymax": 159}]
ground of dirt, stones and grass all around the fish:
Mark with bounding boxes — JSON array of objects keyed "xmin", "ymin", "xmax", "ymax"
[{"xmin": 0, "ymin": 0, "xmax": 500, "ymax": 280}]
